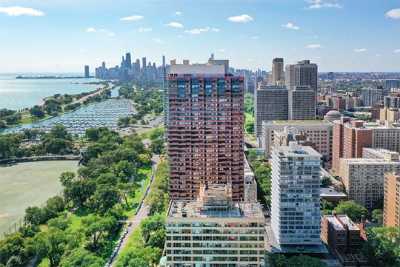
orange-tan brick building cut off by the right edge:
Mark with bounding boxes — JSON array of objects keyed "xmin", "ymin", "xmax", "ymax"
[{"xmin": 383, "ymin": 172, "xmax": 400, "ymax": 227}]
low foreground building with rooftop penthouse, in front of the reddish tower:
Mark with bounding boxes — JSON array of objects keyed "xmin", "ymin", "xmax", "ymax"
[{"xmin": 165, "ymin": 184, "xmax": 265, "ymax": 267}]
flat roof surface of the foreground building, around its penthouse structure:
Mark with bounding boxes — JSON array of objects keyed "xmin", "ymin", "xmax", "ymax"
[{"xmin": 168, "ymin": 201, "xmax": 264, "ymax": 219}]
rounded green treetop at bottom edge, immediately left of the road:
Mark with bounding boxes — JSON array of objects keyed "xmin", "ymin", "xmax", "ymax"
[{"xmin": 60, "ymin": 248, "xmax": 105, "ymax": 267}]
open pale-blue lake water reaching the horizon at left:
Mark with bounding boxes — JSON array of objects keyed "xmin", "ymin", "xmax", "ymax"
[{"xmin": 0, "ymin": 73, "xmax": 99, "ymax": 110}]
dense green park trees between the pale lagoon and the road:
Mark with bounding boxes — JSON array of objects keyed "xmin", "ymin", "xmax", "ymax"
[{"xmin": 0, "ymin": 128, "xmax": 157, "ymax": 267}]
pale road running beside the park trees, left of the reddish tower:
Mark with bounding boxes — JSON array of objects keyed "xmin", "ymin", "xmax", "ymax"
[{"xmin": 105, "ymin": 155, "xmax": 160, "ymax": 267}]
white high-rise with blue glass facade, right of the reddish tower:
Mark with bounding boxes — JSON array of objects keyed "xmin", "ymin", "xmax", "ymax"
[{"xmin": 271, "ymin": 142, "xmax": 321, "ymax": 248}]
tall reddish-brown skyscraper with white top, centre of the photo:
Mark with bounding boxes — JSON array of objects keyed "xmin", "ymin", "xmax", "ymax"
[{"xmin": 167, "ymin": 59, "xmax": 244, "ymax": 201}]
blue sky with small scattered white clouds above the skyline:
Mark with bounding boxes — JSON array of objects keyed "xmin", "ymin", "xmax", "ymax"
[{"xmin": 0, "ymin": 0, "xmax": 400, "ymax": 73}]
